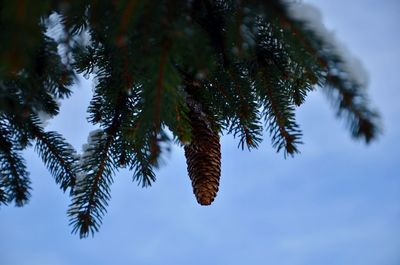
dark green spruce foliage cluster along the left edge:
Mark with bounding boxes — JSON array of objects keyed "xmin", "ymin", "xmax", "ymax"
[{"xmin": 0, "ymin": 1, "xmax": 76, "ymax": 206}]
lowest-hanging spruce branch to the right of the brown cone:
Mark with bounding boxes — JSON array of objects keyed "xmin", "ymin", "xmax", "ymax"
[{"xmin": 250, "ymin": 20, "xmax": 307, "ymax": 157}]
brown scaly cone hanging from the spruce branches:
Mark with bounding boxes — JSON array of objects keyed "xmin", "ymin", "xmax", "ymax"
[{"xmin": 185, "ymin": 98, "xmax": 221, "ymax": 205}]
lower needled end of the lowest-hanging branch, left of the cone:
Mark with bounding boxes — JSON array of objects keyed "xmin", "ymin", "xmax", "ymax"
[{"xmin": 68, "ymin": 126, "xmax": 118, "ymax": 238}]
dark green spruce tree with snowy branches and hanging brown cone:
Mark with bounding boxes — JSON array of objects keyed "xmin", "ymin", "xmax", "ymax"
[{"xmin": 0, "ymin": 0, "xmax": 380, "ymax": 237}]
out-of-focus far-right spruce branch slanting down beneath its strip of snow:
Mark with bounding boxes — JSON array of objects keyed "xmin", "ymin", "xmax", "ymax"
[{"xmin": 266, "ymin": 1, "xmax": 381, "ymax": 143}]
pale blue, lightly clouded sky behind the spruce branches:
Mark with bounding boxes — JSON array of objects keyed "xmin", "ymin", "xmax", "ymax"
[{"xmin": 0, "ymin": 0, "xmax": 400, "ymax": 265}]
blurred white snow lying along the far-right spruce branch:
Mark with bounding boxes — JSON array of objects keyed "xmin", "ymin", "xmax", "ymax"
[{"xmin": 289, "ymin": 2, "xmax": 369, "ymax": 87}]
